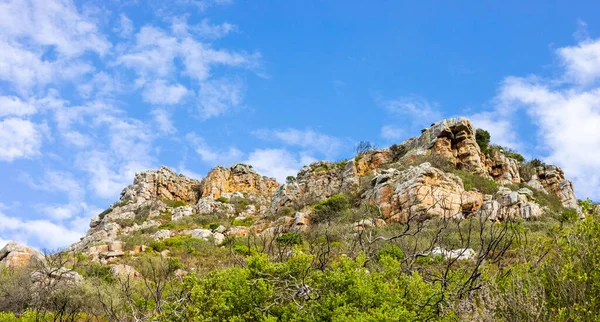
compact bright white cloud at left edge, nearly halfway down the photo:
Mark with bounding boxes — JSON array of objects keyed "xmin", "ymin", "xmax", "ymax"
[{"xmin": 0, "ymin": 118, "xmax": 43, "ymax": 162}]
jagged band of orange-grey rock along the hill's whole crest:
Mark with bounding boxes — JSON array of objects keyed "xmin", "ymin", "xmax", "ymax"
[{"xmin": 63, "ymin": 118, "xmax": 577, "ymax": 263}]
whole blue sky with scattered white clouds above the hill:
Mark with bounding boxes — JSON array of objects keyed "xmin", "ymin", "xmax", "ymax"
[{"xmin": 0, "ymin": 0, "xmax": 600, "ymax": 249}]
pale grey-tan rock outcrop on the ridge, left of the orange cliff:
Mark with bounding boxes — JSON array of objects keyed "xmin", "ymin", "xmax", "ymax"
[{"xmin": 121, "ymin": 166, "xmax": 200, "ymax": 204}]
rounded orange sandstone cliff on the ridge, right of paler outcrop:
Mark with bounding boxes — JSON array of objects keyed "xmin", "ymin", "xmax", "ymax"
[{"xmin": 200, "ymin": 164, "xmax": 279, "ymax": 199}]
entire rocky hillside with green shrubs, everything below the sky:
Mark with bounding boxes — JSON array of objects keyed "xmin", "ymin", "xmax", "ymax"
[{"xmin": 0, "ymin": 119, "xmax": 600, "ymax": 322}]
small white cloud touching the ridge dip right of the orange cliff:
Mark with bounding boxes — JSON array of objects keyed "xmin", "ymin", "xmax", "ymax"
[{"xmin": 243, "ymin": 149, "xmax": 316, "ymax": 182}]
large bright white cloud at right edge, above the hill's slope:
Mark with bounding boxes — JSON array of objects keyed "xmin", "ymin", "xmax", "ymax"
[{"xmin": 499, "ymin": 77, "xmax": 600, "ymax": 199}]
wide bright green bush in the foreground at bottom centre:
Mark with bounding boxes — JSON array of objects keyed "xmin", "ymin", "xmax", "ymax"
[{"xmin": 162, "ymin": 252, "xmax": 455, "ymax": 321}]
